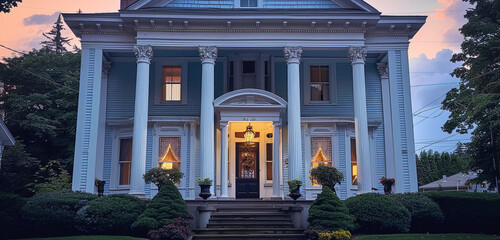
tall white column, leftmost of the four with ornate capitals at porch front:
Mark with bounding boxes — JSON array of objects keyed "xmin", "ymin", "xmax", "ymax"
[{"xmin": 129, "ymin": 46, "xmax": 153, "ymax": 196}]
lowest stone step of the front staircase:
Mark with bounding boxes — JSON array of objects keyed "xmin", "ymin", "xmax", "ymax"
[{"xmin": 193, "ymin": 228, "xmax": 304, "ymax": 234}]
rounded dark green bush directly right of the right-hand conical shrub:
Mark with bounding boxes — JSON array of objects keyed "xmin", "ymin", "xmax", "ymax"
[{"xmin": 345, "ymin": 193, "xmax": 411, "ymax": 233}]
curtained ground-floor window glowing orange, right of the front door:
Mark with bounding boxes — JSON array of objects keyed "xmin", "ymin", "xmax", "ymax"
[{"xmin": 311, "ymin": 137, "xmax": 333, "ymax": 186}]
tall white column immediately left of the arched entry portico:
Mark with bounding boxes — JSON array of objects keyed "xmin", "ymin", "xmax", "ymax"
[{"xmin": 199, "ymin": 47, "xmax": 217, "ymax": 195}]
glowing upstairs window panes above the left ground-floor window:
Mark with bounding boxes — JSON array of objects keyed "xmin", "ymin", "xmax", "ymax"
[{"xmin": 162, "ymin": 66, "xmax": 181, "ymax": 101}]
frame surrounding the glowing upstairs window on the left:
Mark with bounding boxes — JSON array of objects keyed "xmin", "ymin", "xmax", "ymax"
[{"xmin": 154, "ymin": 58, "xmax": 189, "ymax": 105}]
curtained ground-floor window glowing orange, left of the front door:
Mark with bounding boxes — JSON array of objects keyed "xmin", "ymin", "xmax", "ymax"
[{"xmin": 158, "ymin": 137, "xmax": 181, "ymax": 170}]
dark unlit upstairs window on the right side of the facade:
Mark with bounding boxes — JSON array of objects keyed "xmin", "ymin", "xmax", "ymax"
[{"xmin": 310, "ymin": 66, "xmax": 330, "ymax": 102}]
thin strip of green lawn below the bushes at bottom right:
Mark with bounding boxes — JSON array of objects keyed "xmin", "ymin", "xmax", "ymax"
[{"xmin": 356, "ymin": 233, "xmax": 495, "ymax": 240}]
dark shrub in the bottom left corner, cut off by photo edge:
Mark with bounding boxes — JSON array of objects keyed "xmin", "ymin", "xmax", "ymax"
[{"xmin": 0, "ymin": 192, "xmax": 26, "ymax": 239}]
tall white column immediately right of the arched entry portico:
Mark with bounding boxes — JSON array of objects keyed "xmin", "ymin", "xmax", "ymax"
[{"xmin": 284, "ymin": 47, "xmax": 302, "ymax": 180}]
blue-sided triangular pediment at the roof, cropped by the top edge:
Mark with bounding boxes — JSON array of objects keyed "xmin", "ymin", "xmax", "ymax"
[{"xmin": 127, "ymin": 0, "xmax": 378, "ymax": 12}]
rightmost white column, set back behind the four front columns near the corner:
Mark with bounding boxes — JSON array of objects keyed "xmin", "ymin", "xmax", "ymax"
[{"xmin": 377, "ymin": 62, "xmax": 396, "ymax": 178}]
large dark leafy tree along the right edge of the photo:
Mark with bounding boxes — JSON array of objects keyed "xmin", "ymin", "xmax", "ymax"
[{"xmin": 442, "ymin": 0, "xmax": 500, "ymax": 193}]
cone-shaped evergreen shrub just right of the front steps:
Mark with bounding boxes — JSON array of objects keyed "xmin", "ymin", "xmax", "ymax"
[{"xmin": 307, "ymin": 186, "xmax": 354, "ymax": 231}]
